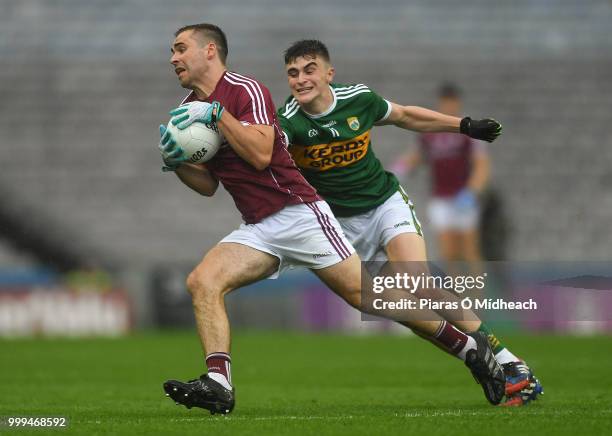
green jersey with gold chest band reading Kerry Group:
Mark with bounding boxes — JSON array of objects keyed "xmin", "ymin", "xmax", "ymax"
[{"xmin": 278, "ymin": 84, "xmax": 398, "ymax": 217}]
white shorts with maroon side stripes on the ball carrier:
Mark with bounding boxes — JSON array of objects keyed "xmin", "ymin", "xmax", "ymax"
[{"xmin": 219, "ymin": 201, "xmax": 355, "ymax": 279}]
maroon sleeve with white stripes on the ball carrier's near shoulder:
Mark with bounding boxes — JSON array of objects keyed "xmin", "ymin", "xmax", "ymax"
[{"xmin": 232, "ymin": 79, "xmax": 275, "ymax": 126}]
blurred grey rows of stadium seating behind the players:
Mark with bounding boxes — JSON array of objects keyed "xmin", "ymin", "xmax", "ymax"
[{"xmin": 0, "ymin": 0, "xmax": 612, "ymax": 330}]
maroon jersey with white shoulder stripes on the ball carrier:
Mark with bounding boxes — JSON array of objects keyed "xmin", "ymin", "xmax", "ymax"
[{"xmin": 183, "ymin": 71, "xmax": 321, "ymax": 224}]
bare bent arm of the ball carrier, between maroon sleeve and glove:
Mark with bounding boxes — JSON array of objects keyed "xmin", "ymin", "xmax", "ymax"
[{"xmin": 217, "ymin": 111, "xmax": 274, "ymax": 171}]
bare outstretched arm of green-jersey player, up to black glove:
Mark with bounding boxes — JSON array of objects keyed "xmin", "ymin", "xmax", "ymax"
[{"xmin": 376, "ymin": 103, "xmax": 461, "ymax": 133}]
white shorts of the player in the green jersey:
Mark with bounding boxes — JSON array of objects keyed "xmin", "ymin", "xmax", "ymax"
[{"xmin": 338, "ymin": 188, "xmax": 422, "ymax": 261}]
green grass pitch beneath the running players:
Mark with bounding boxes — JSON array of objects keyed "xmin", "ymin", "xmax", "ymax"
[{"xmin": 0, "ymin": 331, "xmax": 612, "ymax": 436}]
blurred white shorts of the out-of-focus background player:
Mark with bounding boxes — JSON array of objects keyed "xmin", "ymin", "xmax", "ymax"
[{"xmin": 428, "ymin": 197, "xmax": 480, "ymax": 232}]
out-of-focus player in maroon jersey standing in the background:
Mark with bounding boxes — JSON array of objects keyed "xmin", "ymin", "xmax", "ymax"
[{"xmin": 392, "ymin": 83, "xmax": 490, "ymax": 264}]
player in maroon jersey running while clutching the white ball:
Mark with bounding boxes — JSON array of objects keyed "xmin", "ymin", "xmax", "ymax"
[{"xmin": 159, "ymin": 24, "xmax": 506, "ymax": 414}]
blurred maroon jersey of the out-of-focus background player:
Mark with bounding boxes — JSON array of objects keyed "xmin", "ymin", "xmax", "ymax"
[{"xmin": 421, "ymin": 132, "xmax": 485, "ymax": 197}]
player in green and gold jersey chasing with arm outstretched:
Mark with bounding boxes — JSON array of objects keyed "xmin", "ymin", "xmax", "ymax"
[{"xmin": 278, "ymin": 40, "xmax": 541, "ymax": 404}]
